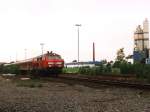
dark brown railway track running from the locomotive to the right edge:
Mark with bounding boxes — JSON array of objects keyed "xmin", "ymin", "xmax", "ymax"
[{"xmin": 59, "ymin": 75, "xmax": 150, "ymax": 89}]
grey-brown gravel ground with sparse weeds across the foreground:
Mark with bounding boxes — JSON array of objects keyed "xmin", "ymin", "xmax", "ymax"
[{"xmin": 0, "ymin": 77, "xmax": 150, "ymax": 112}]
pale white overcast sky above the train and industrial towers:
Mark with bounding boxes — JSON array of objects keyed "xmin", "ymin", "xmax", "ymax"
[{"xmin": 0, "ymin": 0, "xmax": 150, "ymax": 62}]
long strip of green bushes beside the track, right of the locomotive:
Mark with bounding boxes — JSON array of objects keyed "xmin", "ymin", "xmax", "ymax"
[{"xmin": 65, "ymin": 61, "xmax": 150, "ymax": 81}]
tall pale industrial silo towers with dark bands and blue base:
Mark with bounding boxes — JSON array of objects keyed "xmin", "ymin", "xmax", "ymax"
[{"xmin": 133, "ymin": 19, "xmax": 150, "ymax": 63}]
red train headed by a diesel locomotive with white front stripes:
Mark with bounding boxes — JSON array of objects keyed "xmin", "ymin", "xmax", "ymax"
[{"xmin": 8, "ymin": 51, "xmax": 64, "ymax": 74}]
